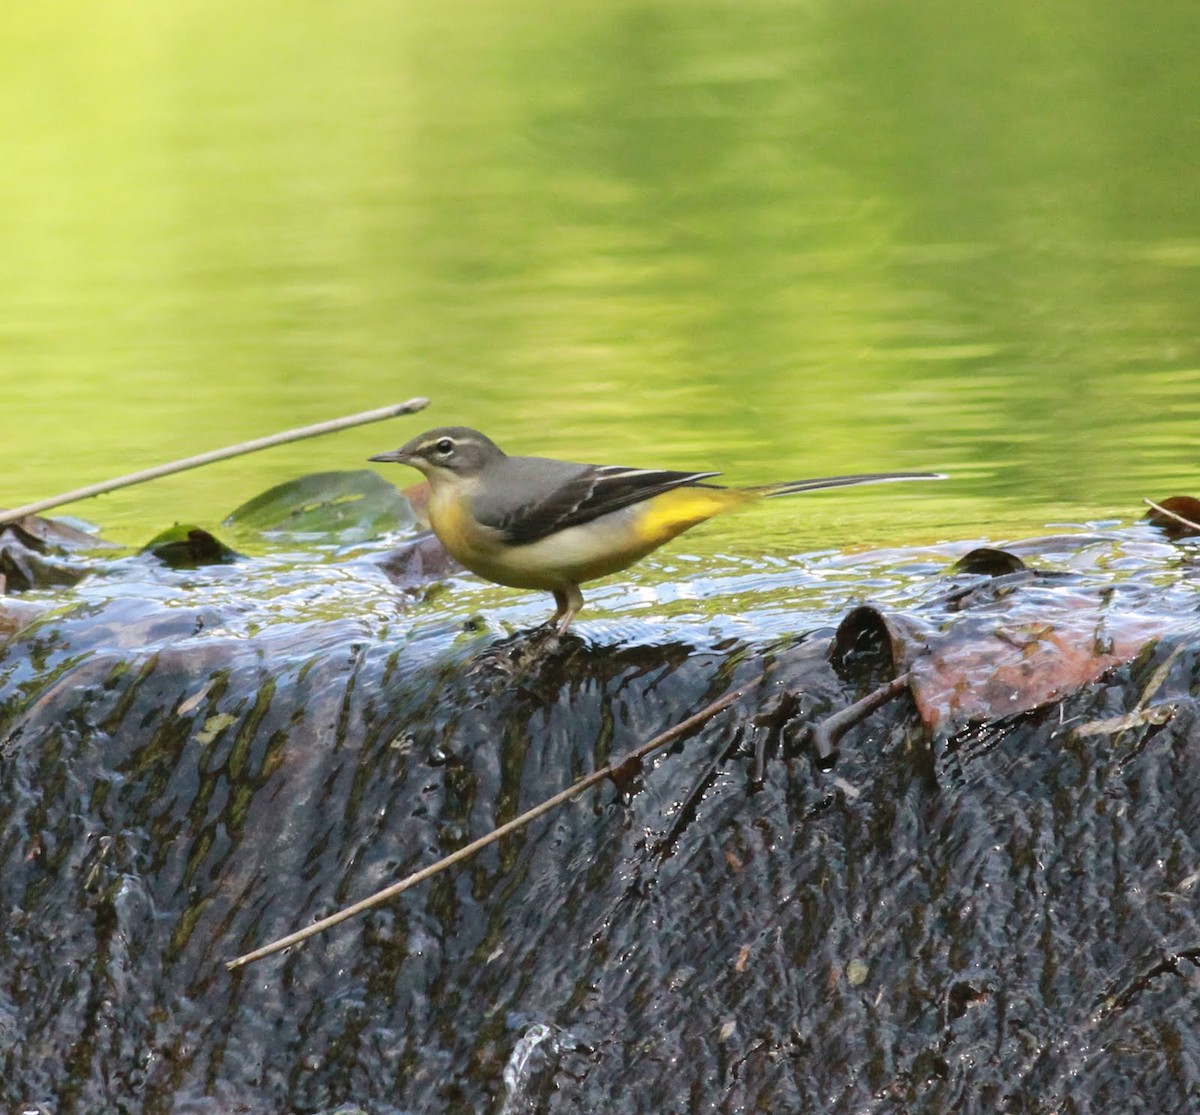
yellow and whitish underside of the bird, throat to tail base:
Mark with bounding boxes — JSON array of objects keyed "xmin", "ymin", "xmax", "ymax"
[{"xmin": 430, "ymin": 487, "xmax": 758, "ymax": 591}]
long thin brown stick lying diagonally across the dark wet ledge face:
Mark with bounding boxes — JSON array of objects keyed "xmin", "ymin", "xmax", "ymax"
[{"xmin": 226, "ymin": 675, "xmax": 762, "ymax": 971}]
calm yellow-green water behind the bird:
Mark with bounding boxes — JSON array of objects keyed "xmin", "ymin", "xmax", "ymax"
[{"xmin": 0, "ymin": 0, "xmax": 1200, "ymax": 553}]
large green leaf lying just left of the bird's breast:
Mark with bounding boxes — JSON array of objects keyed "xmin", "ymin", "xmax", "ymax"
[{"xmin": 224, "ymin": 469, "xmax": 415, "ymax": 542}]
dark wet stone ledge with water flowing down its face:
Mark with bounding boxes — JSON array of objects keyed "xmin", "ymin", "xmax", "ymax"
[{"xmin": 0, "ymin": 532, "xmax": 1200, "ymax": 1113}]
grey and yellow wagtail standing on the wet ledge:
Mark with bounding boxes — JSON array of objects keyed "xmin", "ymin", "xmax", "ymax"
[{"xmin": 371, "ymin": 426, "xmax": 942, "ymax": 634}]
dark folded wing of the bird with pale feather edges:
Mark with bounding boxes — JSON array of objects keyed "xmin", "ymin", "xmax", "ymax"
[{"xmin": 474, "ymin": 457, "xmax": 716, "ymax": 546}]
